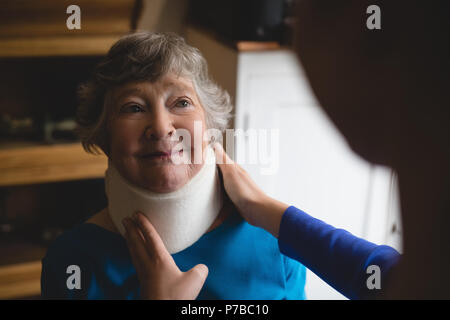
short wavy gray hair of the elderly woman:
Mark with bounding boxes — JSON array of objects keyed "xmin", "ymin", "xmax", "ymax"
[{"xmin": 76, "ymin": 32, "xmax": 233, "ymax": 154}]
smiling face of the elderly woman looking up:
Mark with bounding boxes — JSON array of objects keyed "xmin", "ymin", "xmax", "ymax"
[{"xmin": 105, "ymin": 73, "xmax": 207, "ymax": 193}]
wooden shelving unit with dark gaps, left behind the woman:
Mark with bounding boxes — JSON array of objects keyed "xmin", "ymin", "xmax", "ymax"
[{"xmin": 0, "ymin": 0, "xmax": 142, "ymax": 299}]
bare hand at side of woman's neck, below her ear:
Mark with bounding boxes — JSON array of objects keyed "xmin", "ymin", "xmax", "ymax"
[{"xmin": 213, "ymin": 143, "xmax": 289, "ymax": 237}]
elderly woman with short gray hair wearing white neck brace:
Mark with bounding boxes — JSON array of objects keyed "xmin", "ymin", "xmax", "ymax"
[{"xmin": 41, "ymin": 32, "xmax": 306, "ymax": 299}]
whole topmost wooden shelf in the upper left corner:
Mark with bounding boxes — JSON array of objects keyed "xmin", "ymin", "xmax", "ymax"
[{"xmin": 0, "ymin": 0, "xmax": 141, "ymax": 57}]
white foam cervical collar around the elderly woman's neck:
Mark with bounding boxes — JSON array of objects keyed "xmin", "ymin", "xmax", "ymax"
[{"xmin": 105, "ymin": 147, "xmax": 223, "ymax": 254}]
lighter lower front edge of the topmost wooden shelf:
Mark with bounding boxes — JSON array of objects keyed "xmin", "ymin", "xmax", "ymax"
[{"xmin": 0, "ymin": 35, "xmax": 120, "ymax": 58}]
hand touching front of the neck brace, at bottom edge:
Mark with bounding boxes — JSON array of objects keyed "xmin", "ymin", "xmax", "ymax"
[{"xmin": 123, "ymin": 213, "xmax": 208, "ymax": 300}]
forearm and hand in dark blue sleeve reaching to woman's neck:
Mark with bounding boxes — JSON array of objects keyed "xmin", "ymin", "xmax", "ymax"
[{"xmin": 214, "ymin": 144, "xmax": 400, "ymax": 299}]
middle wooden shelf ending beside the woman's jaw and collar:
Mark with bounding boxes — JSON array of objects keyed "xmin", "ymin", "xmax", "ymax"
[{"xmin": 0, "ymin": 143, "xmax": 107, "ymax": 186}]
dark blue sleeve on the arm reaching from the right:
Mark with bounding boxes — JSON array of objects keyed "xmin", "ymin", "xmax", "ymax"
[{"xmin": 278, "ymin": 206, "xmax": 400, "ymax": 299}]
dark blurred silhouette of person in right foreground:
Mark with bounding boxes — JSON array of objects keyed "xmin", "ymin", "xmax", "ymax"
[{"xmin": 295, "ymin": 0, "xmax": 450, "ymax": 299}]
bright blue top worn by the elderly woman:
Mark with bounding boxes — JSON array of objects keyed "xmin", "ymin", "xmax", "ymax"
[{"xmin": 41, "ymin": 215, "xmax": 306, "ymax": 300}]
